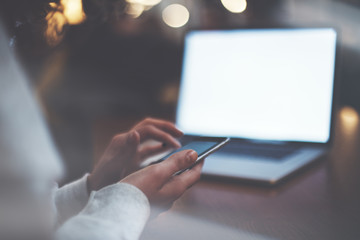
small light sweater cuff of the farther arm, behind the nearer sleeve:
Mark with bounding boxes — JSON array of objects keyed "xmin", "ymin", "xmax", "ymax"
[{"xmin": 54, "ymin": 174, "xmax": 89, "ymax": 226}]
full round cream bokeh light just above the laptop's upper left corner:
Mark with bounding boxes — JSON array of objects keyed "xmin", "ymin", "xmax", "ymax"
[{"xmin": 162, "ymin": 4, "xmax": 190, "ymax": 28}]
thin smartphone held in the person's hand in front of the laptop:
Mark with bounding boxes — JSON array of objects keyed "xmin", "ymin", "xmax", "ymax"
[{"xmin": 154, "ymin": 137, "xmax": 230, "ymax": 175}]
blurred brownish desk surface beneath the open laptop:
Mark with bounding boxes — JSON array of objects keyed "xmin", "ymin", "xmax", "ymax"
[{"xmin": 137, "ymin": 108, "xmax": 360, "ymax": 240}]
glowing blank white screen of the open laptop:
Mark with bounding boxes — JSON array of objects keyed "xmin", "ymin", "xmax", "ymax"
[{"xmin": 176, "ymin": 28, "xmax": 336, "ymax": 143}]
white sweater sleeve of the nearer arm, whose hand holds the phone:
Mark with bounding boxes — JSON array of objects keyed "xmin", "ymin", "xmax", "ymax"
[{"xmin": 56, "ymin": 183, "xmax": 150, "ymax": 240}]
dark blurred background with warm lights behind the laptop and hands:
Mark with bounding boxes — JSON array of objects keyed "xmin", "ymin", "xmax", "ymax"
[{"xmin": 0, "ymin": 0, "xmax": 360, "ymax": 182}]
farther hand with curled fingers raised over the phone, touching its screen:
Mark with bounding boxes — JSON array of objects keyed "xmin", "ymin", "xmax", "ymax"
[{"xmin": 88, "ymin": 118, "xmax": 183, "ymax": 192}]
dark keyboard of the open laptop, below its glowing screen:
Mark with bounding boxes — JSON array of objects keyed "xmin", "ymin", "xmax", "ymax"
[{"xmin": 221, "ymin": 142, "xmax": 299, "ymax": 160}]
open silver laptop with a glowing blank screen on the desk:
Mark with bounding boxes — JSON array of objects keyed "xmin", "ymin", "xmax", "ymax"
[{"xmin": 176, "ymin": 28, "xmax": 337, "ymax": 184}]
